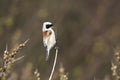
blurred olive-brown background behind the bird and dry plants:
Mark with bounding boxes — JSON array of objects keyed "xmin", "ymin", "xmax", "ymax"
[{"xmin": 0, "ymin": 0, "xmax": 120, "ymax": 80}]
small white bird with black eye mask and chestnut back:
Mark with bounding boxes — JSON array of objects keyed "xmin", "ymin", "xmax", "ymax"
[{"xmin": 42, "ymin": 22, "xmax": 56, "ymax": 61}]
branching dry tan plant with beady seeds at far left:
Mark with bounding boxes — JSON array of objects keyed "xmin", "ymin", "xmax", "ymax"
[{"xmin": 0, "ymin": 39, "xmax": 29, "ymax": 80}]
